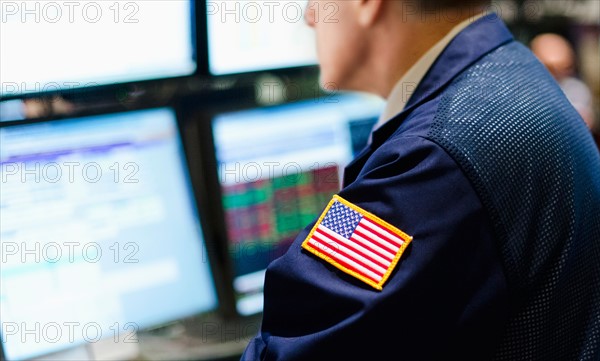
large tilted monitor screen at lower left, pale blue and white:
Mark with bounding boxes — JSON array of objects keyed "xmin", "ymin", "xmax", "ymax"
[{"xmin": 0, "ymin": 108, "xmax": 221, "ymax": 360}]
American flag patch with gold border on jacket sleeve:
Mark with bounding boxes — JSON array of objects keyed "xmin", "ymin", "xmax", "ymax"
[{"xmin": 302, "ymin": 195, "xmax": 412, "ymax": 290}]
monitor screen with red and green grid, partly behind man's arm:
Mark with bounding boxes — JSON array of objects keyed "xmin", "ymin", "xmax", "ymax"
[{"xmin": 212, "ymin": 94, "xmax": 383, "ymax": 316}]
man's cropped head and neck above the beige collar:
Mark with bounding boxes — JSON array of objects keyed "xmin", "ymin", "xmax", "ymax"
[{"xmin": 306, "ymin": 0, "xmax": 489, "ymax": 97}]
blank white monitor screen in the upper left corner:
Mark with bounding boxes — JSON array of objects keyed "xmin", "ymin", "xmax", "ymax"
[{"xmin": 0, "ymin": 0, "xmax": 197, "ymax": 97}]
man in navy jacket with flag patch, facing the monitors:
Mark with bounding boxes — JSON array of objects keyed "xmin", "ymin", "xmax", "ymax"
[{"xmin": 242, "ymin": 0, "xmax": 600, "ymax": 360}]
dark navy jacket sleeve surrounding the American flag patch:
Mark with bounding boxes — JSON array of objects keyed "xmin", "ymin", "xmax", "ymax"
[{"xmin": 242, "ymin": 136, "xmax": 508, "ymax": 360}]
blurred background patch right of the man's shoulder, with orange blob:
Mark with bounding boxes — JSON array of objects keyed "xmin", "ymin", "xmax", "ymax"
[{"xmin": 495, "ymin": 0, "xmax": 600, "ymax": 137}]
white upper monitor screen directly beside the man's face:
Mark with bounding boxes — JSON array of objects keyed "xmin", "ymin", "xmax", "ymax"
[{"xmin": 206, "ymin": 0, "xmax": 316, "ymax": 75}]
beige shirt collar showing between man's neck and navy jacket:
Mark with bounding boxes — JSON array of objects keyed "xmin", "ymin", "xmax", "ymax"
[{"xmin": 373, "ymin": 13, "xmax": 486, "ymax": 130}]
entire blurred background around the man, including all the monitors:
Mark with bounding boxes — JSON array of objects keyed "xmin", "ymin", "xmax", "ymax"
[{"xmin": 0, "ymin": 0, "xmax": 600, "ymax": 361}]
